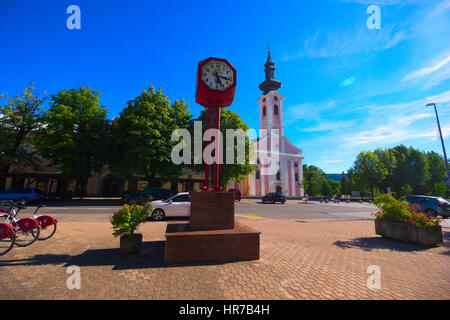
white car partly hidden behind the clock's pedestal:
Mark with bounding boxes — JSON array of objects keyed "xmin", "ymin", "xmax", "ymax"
[{"xmin": 148, "ymin": 192, "xmax": 191, "ymax": 221}]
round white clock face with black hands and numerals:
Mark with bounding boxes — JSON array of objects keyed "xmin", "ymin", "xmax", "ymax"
[{"xmin": 202, "ymin": 60, "xmax": 234, "ymax": 91}]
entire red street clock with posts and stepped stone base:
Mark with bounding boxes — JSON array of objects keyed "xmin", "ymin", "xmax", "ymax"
[{"xmin": 164, "ymin": 58, "xmax": 260, "ymax": 264}]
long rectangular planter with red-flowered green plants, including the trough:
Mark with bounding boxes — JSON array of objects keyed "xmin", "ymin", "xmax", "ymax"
[{"xmin": 373, "ymin": 194, "xmax": 443, "ymax": 246}]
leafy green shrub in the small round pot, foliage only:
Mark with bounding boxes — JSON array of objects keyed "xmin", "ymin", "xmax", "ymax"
[{"xmin": 111, "ymin": 204, "xmax": 153, "ymax": 237}]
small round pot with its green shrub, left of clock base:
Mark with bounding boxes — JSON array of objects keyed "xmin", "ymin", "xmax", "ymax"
[{"xmin": 111, "ymin": 205, "xmax": 151, "ymax": 254}]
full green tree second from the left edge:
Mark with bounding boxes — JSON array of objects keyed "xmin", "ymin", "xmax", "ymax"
[{"xmin": 36, "ymin": 87, "xmax": 108, "ymax": 196}]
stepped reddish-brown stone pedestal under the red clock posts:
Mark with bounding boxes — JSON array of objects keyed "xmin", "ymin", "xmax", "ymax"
[{"xmin": 165, "ymin": 192, "xmax": 261, "ymax": 264}]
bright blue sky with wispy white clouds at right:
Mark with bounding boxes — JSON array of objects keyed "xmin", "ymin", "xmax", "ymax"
[{"xmin": 0, "ymin": 0, "xmax": 450, "ymax": 173}]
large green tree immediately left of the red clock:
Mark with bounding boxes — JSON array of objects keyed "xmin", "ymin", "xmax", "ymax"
[{"xmin": 108, "ymin": 86, "xmax": 191, "ymax": 185}]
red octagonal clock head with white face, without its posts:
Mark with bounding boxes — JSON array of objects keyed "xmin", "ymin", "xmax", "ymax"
[{"xmin": 195, "ymin": 58, "xmax": 236, "ymax": 108}]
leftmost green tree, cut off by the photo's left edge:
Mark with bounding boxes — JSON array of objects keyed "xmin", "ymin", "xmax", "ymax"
[{"xmin": 0, "ymin": 83, "xmax": 44, "ymax": 189}]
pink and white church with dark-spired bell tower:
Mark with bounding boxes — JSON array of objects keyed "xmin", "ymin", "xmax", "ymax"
[{"xmin": 230, "ymin": 50, "xmax": 304, "ymax": 197}]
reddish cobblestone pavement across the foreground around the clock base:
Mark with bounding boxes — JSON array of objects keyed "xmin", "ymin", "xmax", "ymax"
[{"xmin": 0, "ymin": 219, "xmax": 450, "ymax": 300}]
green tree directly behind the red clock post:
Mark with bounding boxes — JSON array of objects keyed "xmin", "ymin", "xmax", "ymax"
[{"xmin": 190, "ymin": 108, "xmax": 258, "ymax": 187}]
